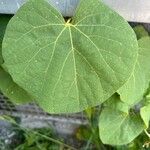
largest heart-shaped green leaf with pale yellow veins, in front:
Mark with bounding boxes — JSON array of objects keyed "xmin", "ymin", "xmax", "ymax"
[{"xmin": 3, "ymin": 0, "xmax": 138, "ymax": 113}]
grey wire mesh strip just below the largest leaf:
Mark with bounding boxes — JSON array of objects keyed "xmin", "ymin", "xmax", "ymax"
[{"xmin": 0, "ymin": 93, "xmax": 87, "ymax": 124}]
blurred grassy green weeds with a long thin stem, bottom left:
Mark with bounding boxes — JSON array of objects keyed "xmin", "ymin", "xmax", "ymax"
[{"xmin": 0, "ymin": 115, "xmax": 77, "ymax": 150}]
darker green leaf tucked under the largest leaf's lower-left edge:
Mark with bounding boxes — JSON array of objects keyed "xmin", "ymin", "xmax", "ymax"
[{"xmin": 0, "ymin": 67, "xmax": 33, "ymax": 104}]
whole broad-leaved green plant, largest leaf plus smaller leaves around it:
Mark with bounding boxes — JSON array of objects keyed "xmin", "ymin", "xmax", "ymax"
[{"xmin": 0, "ymin": 0, "xmax": 150, "ymax": 145}]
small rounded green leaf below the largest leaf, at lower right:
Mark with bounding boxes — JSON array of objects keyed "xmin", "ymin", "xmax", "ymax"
[{"xmin": 99, "ymin": 97, "xmax": 146, "ymax": 145}]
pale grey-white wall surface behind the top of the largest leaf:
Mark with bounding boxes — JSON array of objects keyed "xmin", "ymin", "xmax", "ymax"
[{"xmin": 0, "ymin": 0, "xmax": 150, "ymax": 23}]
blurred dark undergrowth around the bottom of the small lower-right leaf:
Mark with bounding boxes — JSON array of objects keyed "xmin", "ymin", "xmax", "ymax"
[{"xmin": 76, "ymin": 108, "xmax": 150, "ymax": 150}]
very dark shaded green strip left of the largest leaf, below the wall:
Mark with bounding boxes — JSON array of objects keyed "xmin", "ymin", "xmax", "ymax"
[{"xmin": 0, "ymin": 14, "xmax": 12, "ymax": 65}]
